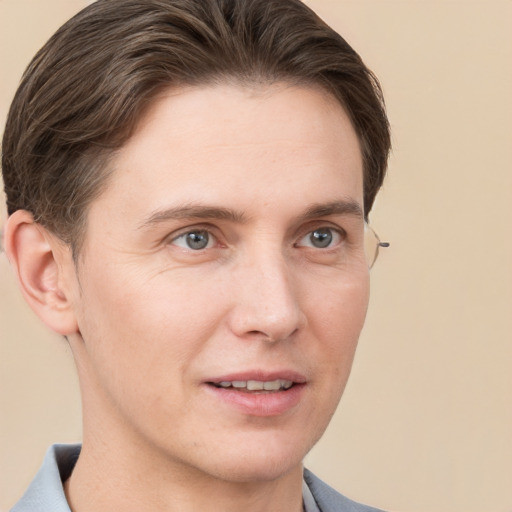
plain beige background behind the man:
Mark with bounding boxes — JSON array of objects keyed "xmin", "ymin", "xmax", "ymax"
[{"xmin": 0, "ymin": 0, "xmax": 512, "ymax": 512}]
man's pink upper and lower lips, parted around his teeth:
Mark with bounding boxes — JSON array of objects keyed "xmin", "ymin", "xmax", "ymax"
[{"xmin": 204, "ymin": 370, "xmax": 307, "ymax": 417}]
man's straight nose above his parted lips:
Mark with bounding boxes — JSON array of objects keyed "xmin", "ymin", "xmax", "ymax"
[{"xmin": 230, "ymin": 250, "xmax": 306, "ymax": 342}]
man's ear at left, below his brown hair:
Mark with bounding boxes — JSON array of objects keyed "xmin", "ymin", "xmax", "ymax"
[{"xmin": 4, "ymin": 210, "xmax": 78, "ymax": 336}]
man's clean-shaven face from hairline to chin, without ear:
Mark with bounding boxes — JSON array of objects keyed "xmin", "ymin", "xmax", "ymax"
[{"xmin": 66, "ymin": 85, "xmax": 368, "ymax": 481}]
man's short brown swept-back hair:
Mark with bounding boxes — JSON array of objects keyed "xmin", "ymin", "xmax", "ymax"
[{"xmin": 2, "ymin": 0, "xmax": 390, "ymax": 252}]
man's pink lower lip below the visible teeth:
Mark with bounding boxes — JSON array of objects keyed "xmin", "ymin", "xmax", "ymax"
[{"xmin": 206, "ymin": 384, "xmax": 306, "ymax": 417}]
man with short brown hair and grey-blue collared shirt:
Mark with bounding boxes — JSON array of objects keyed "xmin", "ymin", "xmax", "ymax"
[{"xmin": 2, "ymin": 0, "xmax": 390, "ymax": 512}]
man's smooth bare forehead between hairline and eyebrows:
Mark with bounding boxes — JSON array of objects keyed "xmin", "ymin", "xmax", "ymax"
[{"xmin": 85, "ymin": 84, "xmax": 363, "ymax": 235}]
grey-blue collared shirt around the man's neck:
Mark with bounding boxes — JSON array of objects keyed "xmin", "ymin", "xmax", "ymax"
[{"xmin": 11, "ymin": 444, "xmax": 381, "ymax": 512}]
